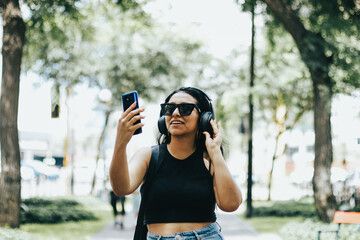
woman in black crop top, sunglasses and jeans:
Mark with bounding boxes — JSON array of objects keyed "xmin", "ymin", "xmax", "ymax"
[{"xmin": 110, "ymin": 87, "xmax": 242, "ymax": 240}]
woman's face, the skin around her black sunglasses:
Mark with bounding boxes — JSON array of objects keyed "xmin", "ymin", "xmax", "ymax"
[{"xmin": 165, "ymin": 92, "xmax": 199, "ymax": 136}]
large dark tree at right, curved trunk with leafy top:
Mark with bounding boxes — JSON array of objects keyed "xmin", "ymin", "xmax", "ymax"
[{"xmin": 256, "ymin": 0, "xmax": 360, "ymax": 222}]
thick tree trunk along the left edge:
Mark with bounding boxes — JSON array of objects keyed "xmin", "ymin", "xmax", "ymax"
[{"xmin": 0, "ymin": 0, "xmax": 25, "ymax": 228}]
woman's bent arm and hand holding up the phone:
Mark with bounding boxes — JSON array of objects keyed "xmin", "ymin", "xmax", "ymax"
[{"xmin": 109, "ymin": 103, "xmax": 151, "ymax": 196}]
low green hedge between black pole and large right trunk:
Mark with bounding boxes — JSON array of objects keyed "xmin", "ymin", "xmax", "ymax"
[{"xmin": 253, "ymin": 200, "xmax": 316, "ymax": 218}]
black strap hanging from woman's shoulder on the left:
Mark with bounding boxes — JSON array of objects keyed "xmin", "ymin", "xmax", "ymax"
[{"xmin": 134, "ymin": 144, "xmax": 166, "ymax": 240}]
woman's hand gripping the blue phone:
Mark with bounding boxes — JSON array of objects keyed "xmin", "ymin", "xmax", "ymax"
[{"xmin": 116, "ymin": 103, "xmax": 145, "ymax": 146}]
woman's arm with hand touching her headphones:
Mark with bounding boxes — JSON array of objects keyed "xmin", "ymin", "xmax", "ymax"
[{"xmin": 204, "ymin": 120, "xmax": 242, "ymax": 212}]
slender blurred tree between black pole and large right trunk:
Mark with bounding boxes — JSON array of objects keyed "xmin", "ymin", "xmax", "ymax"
[{"xmin": 256, "ymin": 32, "xmax": 312, "ymax": 200}]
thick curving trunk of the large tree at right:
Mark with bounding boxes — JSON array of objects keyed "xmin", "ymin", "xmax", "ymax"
[{"xmin": 264, "ymin": 0, "xmax": 336, "ymax": 222}]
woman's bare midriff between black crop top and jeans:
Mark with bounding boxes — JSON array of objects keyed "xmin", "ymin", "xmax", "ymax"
[{"xmin": 147, "ymin": 222, "xmax": 212, "ymax": 235}]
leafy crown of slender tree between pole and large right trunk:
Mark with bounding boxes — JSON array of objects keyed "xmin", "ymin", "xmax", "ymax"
[{"xmin": 255, "ymin": 31, "xmax": 313, "ymax": 121}]
